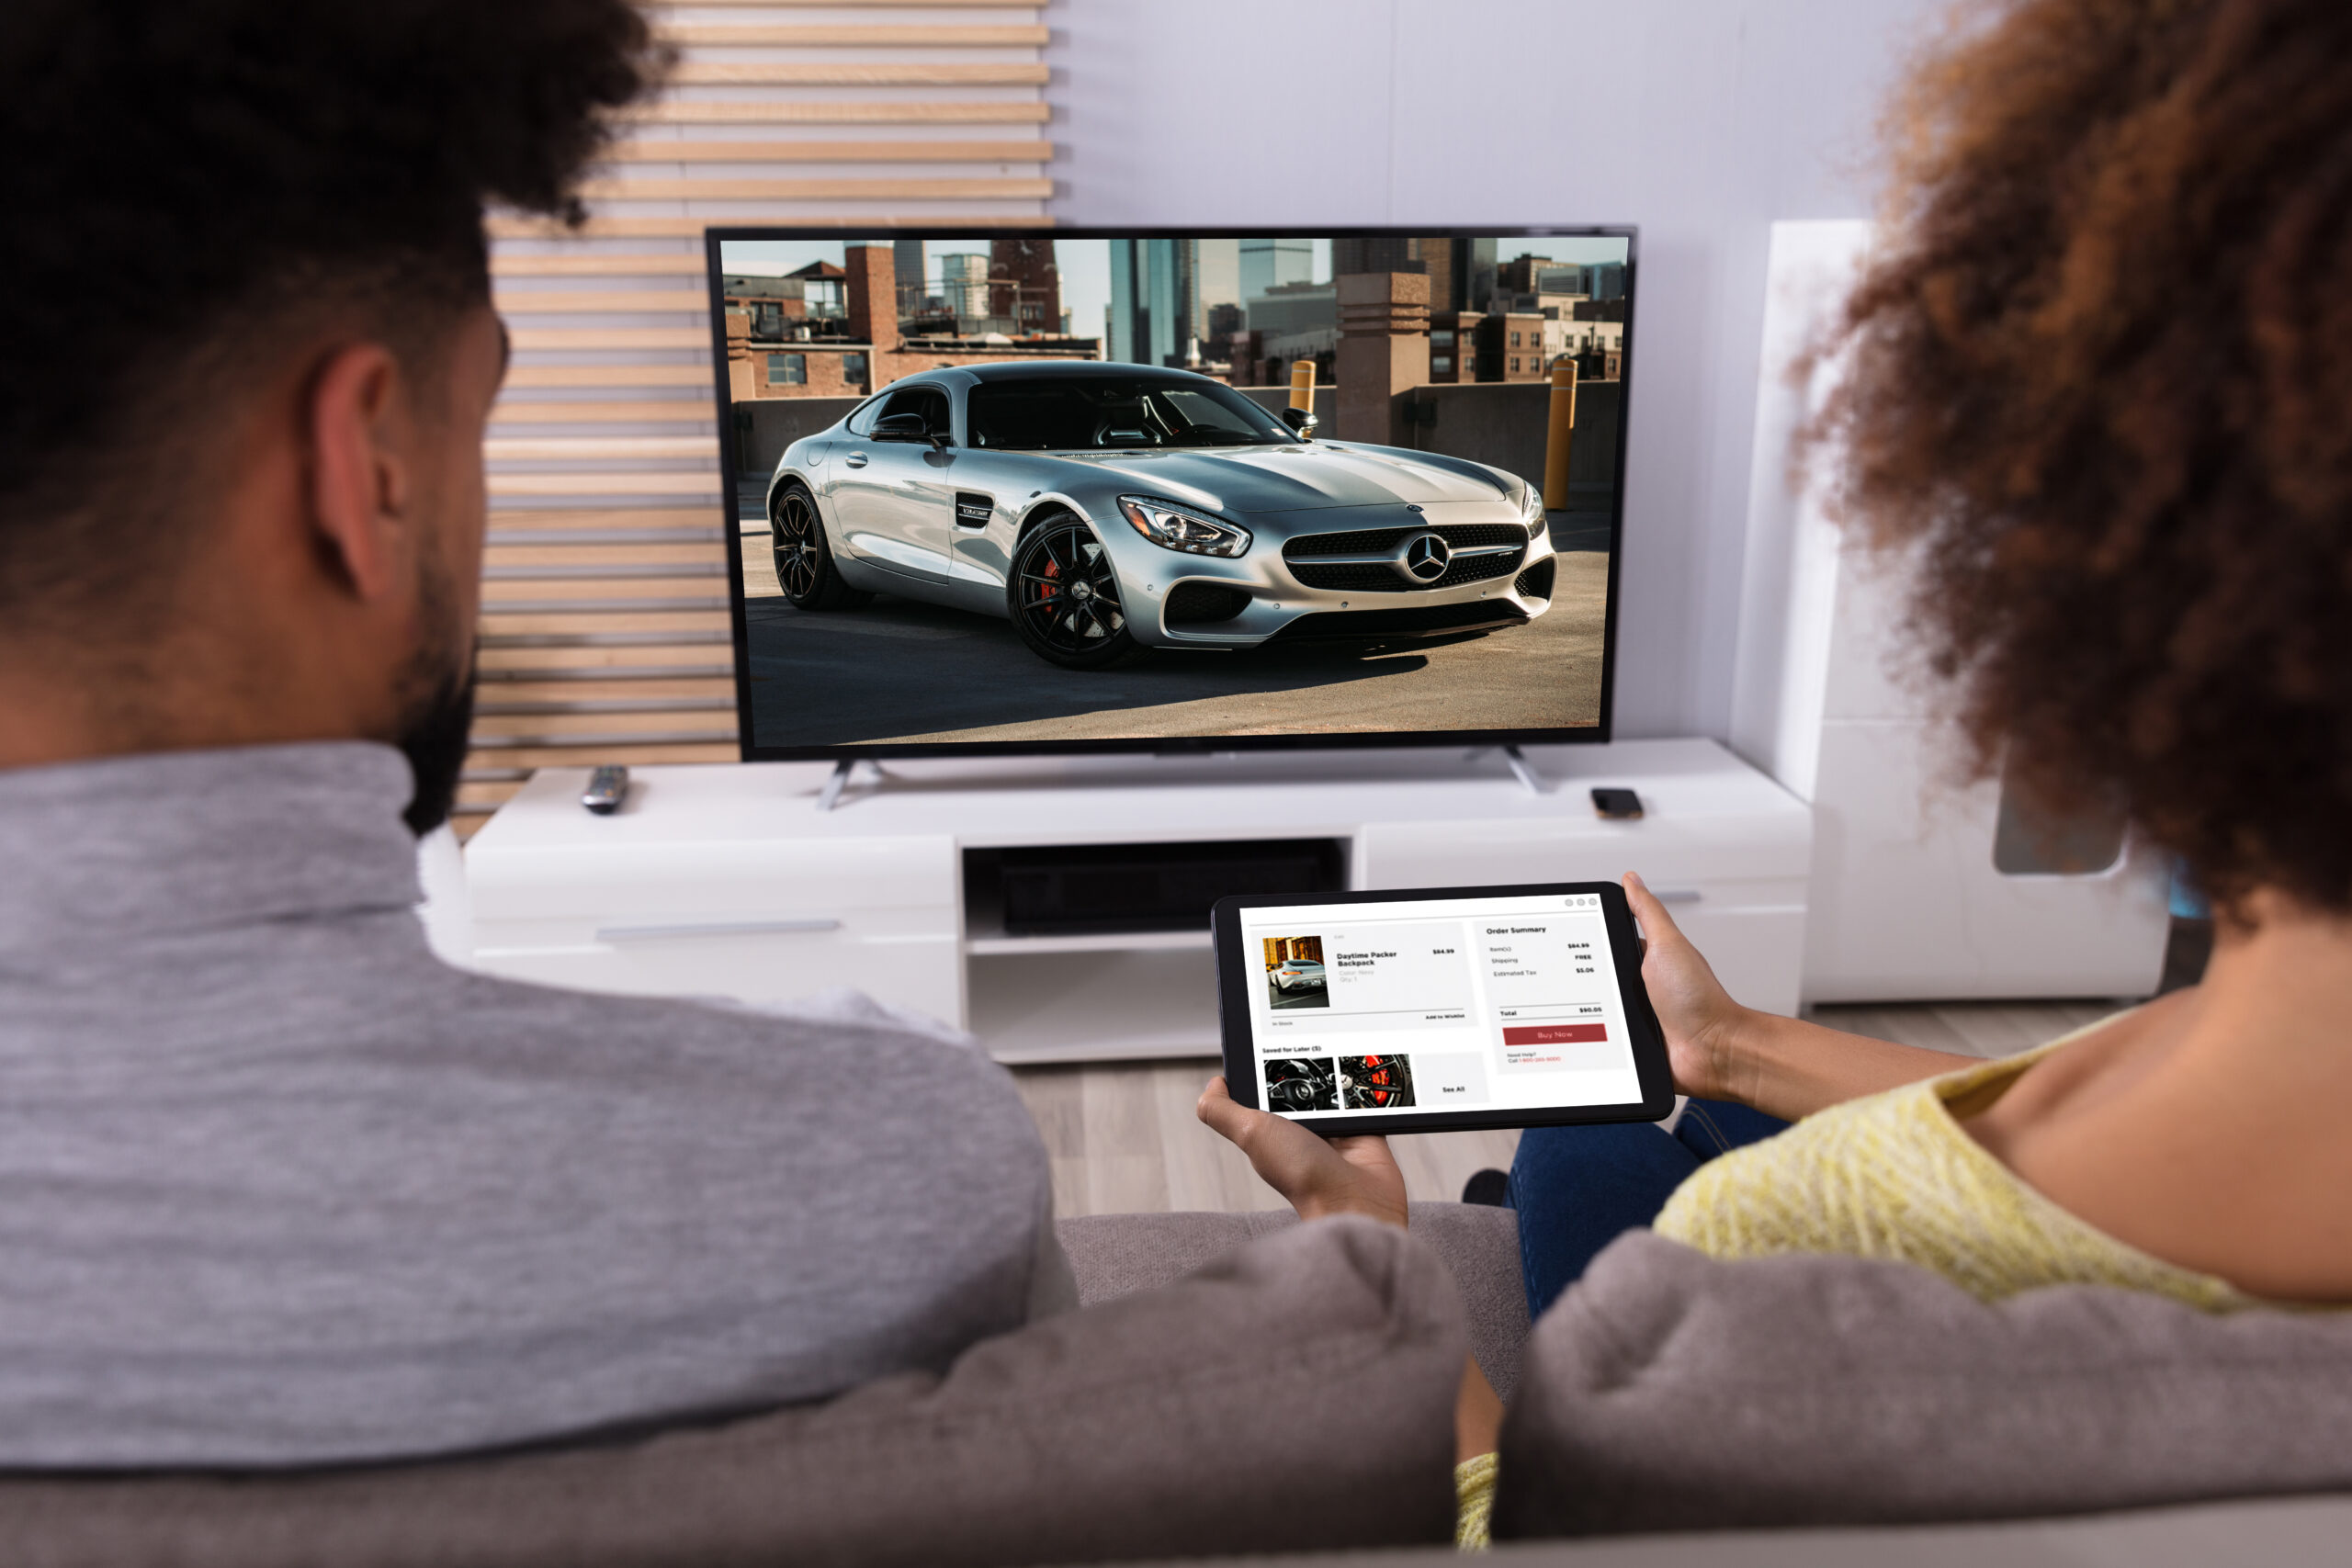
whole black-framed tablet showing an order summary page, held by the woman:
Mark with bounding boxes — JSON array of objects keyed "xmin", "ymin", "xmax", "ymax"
[{"xmin": 1211, "ymin": 882, "xmax": 1675, "ymax": 1134}]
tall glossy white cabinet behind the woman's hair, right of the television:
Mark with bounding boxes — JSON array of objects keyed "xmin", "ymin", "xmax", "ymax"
[{"xmin": 1731, "ymin": 221, "xmax": 2168, "ymax": 1001}]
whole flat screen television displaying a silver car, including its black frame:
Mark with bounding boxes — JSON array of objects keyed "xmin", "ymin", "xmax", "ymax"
[{"xmin": 708, "ymin": 226, "xmax": 1637, "ymax": 761}]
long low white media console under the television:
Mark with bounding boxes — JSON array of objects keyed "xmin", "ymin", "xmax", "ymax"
[{"xmin": 466, "ymin": 740, "xmax": 1814, "ymax": 1063}]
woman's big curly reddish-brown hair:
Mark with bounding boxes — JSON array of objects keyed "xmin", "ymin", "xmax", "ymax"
[{"xmin": 1820, "ymin": 0, "xmax": 2352, "ymax": 912}]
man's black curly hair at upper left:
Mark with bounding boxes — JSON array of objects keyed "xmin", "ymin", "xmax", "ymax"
[{"xmin": 0, "ymin": 0, "xmax": 665, "ymax": 621}]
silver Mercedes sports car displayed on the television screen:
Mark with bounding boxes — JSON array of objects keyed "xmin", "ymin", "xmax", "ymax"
[{"xmin": 767, "ymin": 360, "xmax": 1553, "ymax": 670}]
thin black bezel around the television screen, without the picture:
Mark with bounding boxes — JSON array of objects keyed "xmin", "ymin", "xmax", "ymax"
[{"xmin": 703, "ymin": 223, "xmax": 1642, "ymax": 761}]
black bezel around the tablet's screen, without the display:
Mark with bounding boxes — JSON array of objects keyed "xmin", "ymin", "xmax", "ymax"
[{"xmin": 1209, "ymin": 882, "xmax": 1675, "ymax": 1138}]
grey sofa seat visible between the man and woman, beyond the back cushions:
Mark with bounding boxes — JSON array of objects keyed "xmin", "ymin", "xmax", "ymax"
[{"xmin": 1061, "ymin": 1203, "xmax": 1526, "ymax": 1399}]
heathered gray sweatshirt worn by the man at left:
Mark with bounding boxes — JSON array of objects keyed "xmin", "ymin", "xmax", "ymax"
[{"xmin": 0, "ymin": 743, "xmax": 1068, "ymax": 1470}]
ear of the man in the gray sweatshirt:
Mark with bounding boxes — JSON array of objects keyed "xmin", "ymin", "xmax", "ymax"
[{"xmin": 308, "ymin": 344, "xmax": 416, "ymax": 600}]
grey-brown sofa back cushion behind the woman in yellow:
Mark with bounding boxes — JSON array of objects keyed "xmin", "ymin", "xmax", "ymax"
[{"xmin": 1494, "ymin": 1232, "xmax": 2352, "ymax": 1538}]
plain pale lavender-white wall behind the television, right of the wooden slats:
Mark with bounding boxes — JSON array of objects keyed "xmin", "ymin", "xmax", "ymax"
[{"xmin": 1046, "ymin": 0, "xmax": 1945, "ymax": 739}]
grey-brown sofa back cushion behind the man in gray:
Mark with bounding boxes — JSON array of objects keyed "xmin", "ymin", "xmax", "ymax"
[{"xmin": 0, "ymin": 1220, "xmax": 1465, "ymax": 1568}]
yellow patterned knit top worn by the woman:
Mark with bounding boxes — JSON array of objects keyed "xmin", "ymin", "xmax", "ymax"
[{"xmin": 1654, "ymin": 1025, "xmax": 2260, "ymax": 1312}]
